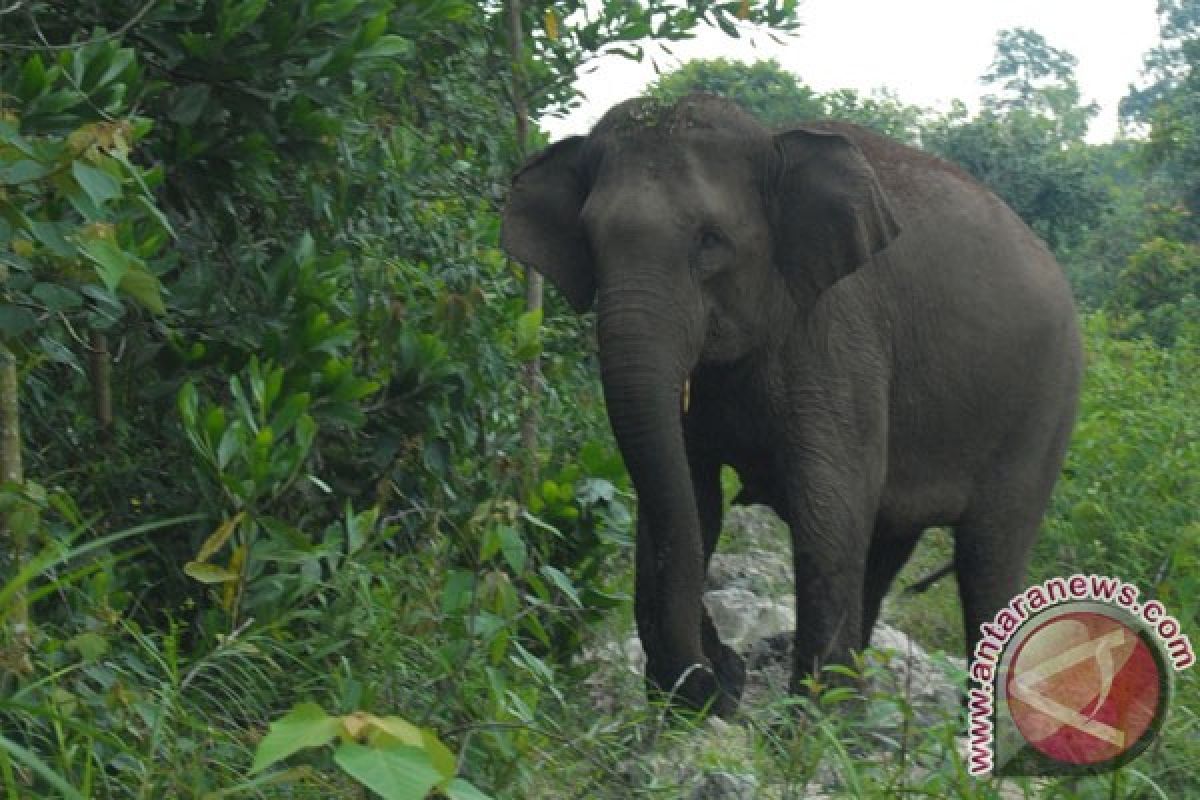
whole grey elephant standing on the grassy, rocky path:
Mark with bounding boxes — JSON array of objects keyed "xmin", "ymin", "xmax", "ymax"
[{"xmin": 503, "ymin": 96, "xmax": 1082, "ymax": 714}]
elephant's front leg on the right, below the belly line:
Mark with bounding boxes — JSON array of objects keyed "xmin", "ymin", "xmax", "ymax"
[{"xmin": 788, "ymin": 462, "xmax": 875, "ymax": 693}]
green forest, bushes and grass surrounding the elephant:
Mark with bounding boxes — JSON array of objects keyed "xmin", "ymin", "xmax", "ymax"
[{"xmin": 0, "ymin": 0, "xmax": 1200, "ymax": 799}]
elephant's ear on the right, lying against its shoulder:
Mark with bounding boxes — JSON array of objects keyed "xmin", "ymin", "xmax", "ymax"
[{"xmin": 772, "ymin": 128, "xmax": 900, "ymax": 305}]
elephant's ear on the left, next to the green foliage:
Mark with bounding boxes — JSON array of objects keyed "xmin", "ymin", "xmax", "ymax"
[{"xmin": 500, "ymin": 137, "xmax": 596, "ymax": 313}]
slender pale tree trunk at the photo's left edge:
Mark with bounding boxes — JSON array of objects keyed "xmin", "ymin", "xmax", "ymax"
[{"xmin": 0, "ymin": 343, "xmax": 32, "ymax": 673}]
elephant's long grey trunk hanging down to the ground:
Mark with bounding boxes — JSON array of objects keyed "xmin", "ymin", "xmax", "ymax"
[{"xmin": 598, "ymin": 290, "xmax": 707, "ymax": 690}]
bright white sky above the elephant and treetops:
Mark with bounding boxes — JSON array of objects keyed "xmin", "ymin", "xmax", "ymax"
[{"xmin": 542, "ymin": 0, "xmax": 1158, "ymax": 142}]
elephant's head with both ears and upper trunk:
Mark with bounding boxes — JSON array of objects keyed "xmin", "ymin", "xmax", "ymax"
[{"xmin": 503, "ymin": 96, "xmax": 895, "ymax": 695}]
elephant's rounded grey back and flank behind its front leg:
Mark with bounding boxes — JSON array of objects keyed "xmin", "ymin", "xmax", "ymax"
[{"xmin": 829, "ymin": 125, "xmax": 1082, "ymax": 522}]
